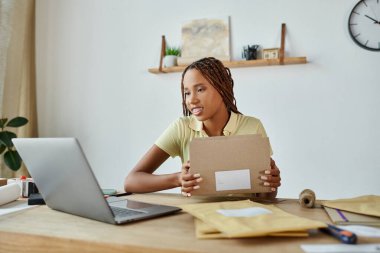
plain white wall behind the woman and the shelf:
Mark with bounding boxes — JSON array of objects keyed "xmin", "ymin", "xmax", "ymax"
[{"xmin": 37, "ymin": 0, "xmax": 380, "ymax": 199}]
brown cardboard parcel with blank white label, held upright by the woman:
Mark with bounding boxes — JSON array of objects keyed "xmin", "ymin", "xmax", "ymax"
[{"xmin": 190, "ymin": 134, "xmax": 271, "ymax": 195}]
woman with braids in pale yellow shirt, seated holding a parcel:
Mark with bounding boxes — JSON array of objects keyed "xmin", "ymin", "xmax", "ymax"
[{"xmin": 124, "ymin": 57, "xmax": 281, "ymax": 198}]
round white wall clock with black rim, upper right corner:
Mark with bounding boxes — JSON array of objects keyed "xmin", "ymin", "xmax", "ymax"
[{"xmin": 348, "ymin": 0, "xmax": 380, "ymax": 51}]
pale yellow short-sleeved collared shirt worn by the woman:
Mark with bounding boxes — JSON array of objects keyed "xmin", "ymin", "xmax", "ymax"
[{"xmin": 155, "ymin": 112, "xmax": 267, "ymax": 163}]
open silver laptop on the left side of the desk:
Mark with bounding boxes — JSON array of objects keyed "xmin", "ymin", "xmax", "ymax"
[{"xmin": 12, "ymin": 138, "xmax": 181, "ymax": 224}]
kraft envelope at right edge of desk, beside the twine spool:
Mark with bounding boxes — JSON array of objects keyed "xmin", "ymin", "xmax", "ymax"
[{"xmin": 322, "ymin": 195, "xmax": 380, "ymax": 217}]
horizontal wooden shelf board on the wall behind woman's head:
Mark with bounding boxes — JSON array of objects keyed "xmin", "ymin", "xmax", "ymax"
[{"xmin": 148, "ymin": 57, "xmax": 307, "ymax": 74}]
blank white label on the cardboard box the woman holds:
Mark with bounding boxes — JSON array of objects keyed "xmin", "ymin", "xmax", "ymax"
[{"xmin": 215, "ymin": 169, "xmax": 251, "ymax": 191}]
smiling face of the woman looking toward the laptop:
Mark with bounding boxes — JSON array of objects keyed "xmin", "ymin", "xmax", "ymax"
[{"xmin": 183, "ymin": 69, "xmax": 226, "ymax": 121}]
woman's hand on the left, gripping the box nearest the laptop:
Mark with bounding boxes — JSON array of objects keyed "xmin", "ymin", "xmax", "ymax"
[{"xmin": 179, "ymin": 161, "xmax": 203, "ymax": 197}]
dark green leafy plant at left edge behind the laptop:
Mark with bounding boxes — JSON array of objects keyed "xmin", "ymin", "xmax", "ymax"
[{"xmin": 0, "ymin": 117, "xmax": 28, "ymax": 171}]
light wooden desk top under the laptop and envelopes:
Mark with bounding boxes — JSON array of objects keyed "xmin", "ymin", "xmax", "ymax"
[{"xmin": 0, "ymin": 193, "xmax": 380, "ymax": 253}]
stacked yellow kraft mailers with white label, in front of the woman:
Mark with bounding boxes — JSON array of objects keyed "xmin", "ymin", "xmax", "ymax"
[{"xmin": 181, "ymin": 200, "xmax": 327, "ymax": 238}]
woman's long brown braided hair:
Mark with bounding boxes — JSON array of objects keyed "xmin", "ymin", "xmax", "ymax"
[{"xmin": 181, "ymin": 57, "xmax": 241, "ymax": 116}]
